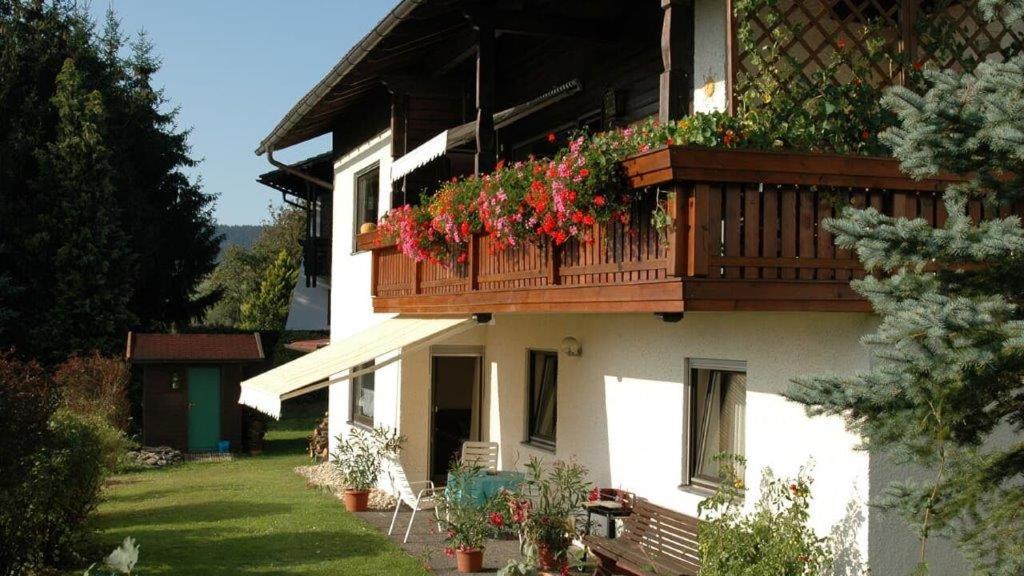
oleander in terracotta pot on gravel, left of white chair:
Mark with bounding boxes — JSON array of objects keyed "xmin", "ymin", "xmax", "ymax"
[{"xmin": 332, "ymin": 426, "xmax": 406, "ymax": 512}]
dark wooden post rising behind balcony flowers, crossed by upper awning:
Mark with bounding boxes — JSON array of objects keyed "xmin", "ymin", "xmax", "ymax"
[{"xmin": 470, "ymin": 10, "xmax": 497, "ymax": 174}]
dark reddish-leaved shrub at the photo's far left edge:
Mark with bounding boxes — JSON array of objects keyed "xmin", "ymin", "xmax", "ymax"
[{"xmin": 0, "ymin": 352, "xmax": 57, "ymax": 576}]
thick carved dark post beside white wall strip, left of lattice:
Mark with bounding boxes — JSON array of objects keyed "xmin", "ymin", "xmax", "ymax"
[{"xmin": 657, "ymin": 0, "xmax": 693, "ymax": 122}]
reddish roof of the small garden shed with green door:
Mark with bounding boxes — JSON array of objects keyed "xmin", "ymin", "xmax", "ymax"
[{"xmin": 125, "ymin": 332, "xmax": 263, "ymax": 362}]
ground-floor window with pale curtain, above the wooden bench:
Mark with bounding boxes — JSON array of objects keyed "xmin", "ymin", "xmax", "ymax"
[{"xmin": 686, "ymin": 361, "xmax": 746, "ymax": 488}]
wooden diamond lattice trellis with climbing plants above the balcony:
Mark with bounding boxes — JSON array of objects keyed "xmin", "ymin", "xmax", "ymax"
[{"xmin": 729, "ymin": 0, "xmax": 1024, "ymax": 104}]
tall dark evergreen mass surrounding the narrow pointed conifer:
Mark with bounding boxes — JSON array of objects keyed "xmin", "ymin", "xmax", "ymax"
[{"xmin": 0, "ymin": 0, "xmax": 218, "ymax": 357}]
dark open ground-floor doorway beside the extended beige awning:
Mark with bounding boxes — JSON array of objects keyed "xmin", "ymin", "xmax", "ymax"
[{"xmin": 430, "ymin": 347, "xmax": 482, "ymax": 484}]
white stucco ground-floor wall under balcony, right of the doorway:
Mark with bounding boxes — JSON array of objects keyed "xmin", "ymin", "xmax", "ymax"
[{"xmin": 485, "ymin": 313, "xmax": 871, "ymax": 552}]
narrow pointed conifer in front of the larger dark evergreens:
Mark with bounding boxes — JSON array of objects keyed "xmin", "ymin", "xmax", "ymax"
[{"xmin": 29, "ymin": 58, "xmax": 133, "ymax": 361}]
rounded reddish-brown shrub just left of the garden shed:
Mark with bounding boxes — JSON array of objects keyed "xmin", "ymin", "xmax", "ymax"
[{"xmin": 53, "ymin": 353, "xmax": 130, "ymax": 430}]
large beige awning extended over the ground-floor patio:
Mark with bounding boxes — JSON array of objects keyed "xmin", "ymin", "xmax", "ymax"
[{"xmin": 239, "ymin": 316, "xmax": 476, "ymax": 418}]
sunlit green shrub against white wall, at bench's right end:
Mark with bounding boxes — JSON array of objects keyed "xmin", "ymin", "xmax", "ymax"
[{"xmin": 697, "ymin": 455, "xmax": 833, "ymax": 576}]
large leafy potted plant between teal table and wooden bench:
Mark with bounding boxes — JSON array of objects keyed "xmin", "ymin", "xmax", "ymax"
[{"xmin": 503, "ymin": 457, "xmax": 591, "ymax": 574}]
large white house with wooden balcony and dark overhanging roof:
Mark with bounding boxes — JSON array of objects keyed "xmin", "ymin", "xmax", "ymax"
[{"xmin": 241, "ymin": 0, "xmax": 1011, "ymax": 574}]
